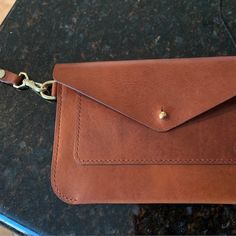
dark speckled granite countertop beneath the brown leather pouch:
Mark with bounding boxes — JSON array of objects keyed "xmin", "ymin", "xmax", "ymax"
[{"xmin": 0, "ymin": 0, "xmax": 236, "ymax": 235}]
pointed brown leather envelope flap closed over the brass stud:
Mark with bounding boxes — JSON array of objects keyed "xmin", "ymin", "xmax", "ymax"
[{"xmin": 54, "ymin": 57, "xmax": 236, "ymax": 131}]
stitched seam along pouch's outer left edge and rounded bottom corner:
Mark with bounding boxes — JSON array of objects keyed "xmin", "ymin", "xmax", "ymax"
[{"xmin": 53, "ymin": 87, "xmax": 78, "ymax": 202}]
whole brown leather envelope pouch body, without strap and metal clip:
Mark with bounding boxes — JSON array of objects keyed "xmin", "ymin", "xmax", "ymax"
[{"xmin": 52, "ymin": 57, "xmax": 236, "ymax": 204}]
